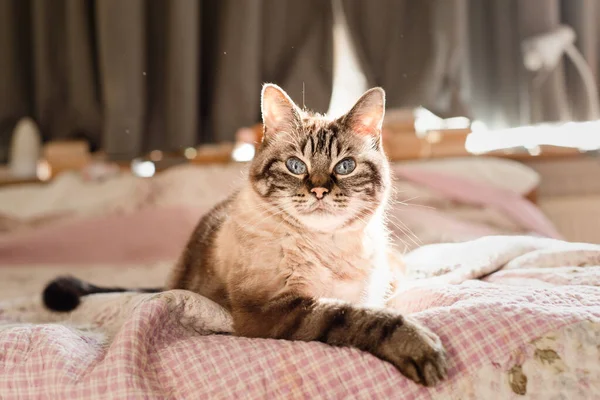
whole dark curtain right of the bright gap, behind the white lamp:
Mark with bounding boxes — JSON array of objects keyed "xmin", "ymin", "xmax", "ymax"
[{"xmin": 341, "ymin": 0, "xmax": 600, "ymax": 128}]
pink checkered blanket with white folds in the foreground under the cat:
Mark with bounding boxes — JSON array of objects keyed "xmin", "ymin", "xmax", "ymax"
[{"xmin": 0, "ymin": 236, "xmax": 600, "ymax": 399}]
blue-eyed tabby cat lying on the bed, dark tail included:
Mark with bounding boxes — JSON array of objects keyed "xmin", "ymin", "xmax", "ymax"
[{"xmin": 44, "ymin": 84, "xmax": 447, "ymax": 386}]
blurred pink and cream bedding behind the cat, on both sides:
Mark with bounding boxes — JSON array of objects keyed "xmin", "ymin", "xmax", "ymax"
[{"xmin": 0, "ymin": 162, "xmax": 560, "ymax": 268}]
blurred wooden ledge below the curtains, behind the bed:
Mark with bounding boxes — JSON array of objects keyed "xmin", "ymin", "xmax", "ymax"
[{"xmin": 0, "ymin": 110, "xmax": 585, "ymax": 186}]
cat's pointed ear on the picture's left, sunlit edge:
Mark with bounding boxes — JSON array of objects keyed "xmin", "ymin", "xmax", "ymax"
[{"xmin": 261, "ymin": 83, "xmax": 301, "ymax": 138}]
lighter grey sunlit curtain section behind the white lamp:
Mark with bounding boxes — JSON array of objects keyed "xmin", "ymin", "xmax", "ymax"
[{"xmin": 466, "ymin": 0, "xmax": 600, "ymax": 128}]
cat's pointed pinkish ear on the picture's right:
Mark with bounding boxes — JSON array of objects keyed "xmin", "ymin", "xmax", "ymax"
[{"xmin": 341, "ymin": 88, "xmax": 385, "ymax": 137}]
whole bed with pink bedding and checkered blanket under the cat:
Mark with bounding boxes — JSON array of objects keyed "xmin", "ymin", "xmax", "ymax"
[{"xmin": 0, "ymin": 159, "xmax": 600, "ymax": 399}]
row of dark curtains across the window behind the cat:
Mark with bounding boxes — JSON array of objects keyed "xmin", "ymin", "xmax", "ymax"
[{"xmin": 0, "ymin": 0, "xmax": 600, "ymax": 162}]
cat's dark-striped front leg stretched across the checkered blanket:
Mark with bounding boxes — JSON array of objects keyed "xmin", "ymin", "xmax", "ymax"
[{"xmin": 232, "ymin": 292, "xmax": 447, "ymax": 386}]
